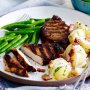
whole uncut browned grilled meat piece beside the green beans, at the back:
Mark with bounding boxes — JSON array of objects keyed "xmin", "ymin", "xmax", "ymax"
[{"xmin": 40, "ymin": 15, "xmax": 69, "ymax": 48}]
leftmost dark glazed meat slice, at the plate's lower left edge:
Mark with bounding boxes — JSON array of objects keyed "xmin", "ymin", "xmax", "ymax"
[{"xmin": 3, "ymin": 55, "xmax": 28, "ymax": 77}]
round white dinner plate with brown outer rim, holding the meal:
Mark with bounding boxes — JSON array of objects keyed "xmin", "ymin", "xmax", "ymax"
[{"xmin": 0, "ymin": 6, "xmax": 90, "ymax": 86}]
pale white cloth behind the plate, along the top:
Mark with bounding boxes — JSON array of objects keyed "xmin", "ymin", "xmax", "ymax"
[{"xmin": 0, "ymin": 0, "xmax": 73, "ymax": 16}]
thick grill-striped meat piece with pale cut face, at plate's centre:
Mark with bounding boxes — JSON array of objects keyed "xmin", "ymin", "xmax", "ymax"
[{"xmin": 21, "ymin": 44, "xmax": 63, "ymax": 65}]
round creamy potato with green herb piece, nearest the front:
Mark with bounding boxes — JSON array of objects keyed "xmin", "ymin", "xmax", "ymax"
[{"xmin": 48, "ymin": 58, "xmax": 71, "ymax": 80}]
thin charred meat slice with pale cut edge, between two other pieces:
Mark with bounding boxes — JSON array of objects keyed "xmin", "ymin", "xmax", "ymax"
[{"xmin": 11, "ymin": 49, "xmax": 36, "ymax": 72}]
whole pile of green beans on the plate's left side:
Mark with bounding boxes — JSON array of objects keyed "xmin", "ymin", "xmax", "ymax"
[{"xmin": 0, "ymin": 18, "xmax": 50, "ymax": 54}]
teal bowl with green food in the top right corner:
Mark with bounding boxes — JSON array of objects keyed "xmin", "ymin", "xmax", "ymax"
[{"xmin": 71, "ymin": 0, "xmax": 90, "ymax": 14}]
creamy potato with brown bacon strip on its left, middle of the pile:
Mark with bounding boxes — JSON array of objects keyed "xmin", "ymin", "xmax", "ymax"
[{"xmin": 65, "ymin": 44, "xmax": 87, "ymax": 68}]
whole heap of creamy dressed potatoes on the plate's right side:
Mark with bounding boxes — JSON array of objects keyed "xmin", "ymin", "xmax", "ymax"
[{"xmin": 48, "ymin": 22, "xmax": 90, "ymax": 80}]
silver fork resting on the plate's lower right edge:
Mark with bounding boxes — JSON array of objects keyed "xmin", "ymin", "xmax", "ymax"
[{"xmin": 72, "ymin": 60, "xmax": 90, "ymax": 90}]
